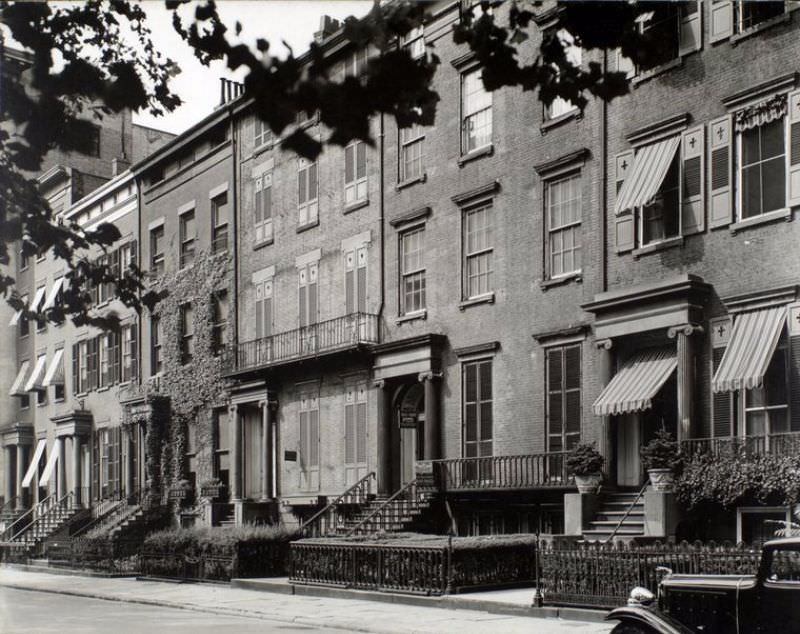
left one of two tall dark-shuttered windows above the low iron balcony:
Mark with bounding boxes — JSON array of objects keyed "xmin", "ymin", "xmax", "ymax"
[{"xmin": 461, "ymin": 359, "xmax": 494, "ymax": 458}]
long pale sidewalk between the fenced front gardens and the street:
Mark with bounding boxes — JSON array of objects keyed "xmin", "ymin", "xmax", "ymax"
[{"xmin": 0, "ymin": 566, "xmax": 613, "ymax": 634}]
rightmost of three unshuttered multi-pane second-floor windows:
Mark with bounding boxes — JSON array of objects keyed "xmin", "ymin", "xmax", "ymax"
[{"xmin": 545, "ymin": 174, "xmax": 581, "ymax": 277}]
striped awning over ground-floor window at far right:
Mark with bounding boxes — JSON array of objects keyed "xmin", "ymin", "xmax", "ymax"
[{"xmin": 711, "ymin": 306, "xmax": 786, "ymax": 392}]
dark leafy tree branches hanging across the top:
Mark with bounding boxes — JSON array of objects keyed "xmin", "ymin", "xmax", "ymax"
[{"xmin": 0, "ymin": 0, "xmax": 670, "ymax": 326}]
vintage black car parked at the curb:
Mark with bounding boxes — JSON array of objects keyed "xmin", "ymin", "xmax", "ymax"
[{"xmin": 606, "ymin": 537, "xmax": 800, "ymax": 634}]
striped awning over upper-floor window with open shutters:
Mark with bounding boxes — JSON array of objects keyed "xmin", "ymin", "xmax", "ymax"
[{"xmin": 614, "ymin": 136, "xmax": 681, "ymax": 214}]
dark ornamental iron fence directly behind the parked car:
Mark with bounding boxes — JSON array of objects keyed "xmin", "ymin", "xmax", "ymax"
[{"xmin": 537, "ymin": 542, "xmax": 761, "ymax": 608}]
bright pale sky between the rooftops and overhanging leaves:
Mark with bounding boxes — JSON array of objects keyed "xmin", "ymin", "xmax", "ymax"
[{"xmin": 133, "ymin": 0, "xmax": 372, "ymax": 133}]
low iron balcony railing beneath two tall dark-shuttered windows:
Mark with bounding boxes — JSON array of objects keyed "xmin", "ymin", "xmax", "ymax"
[{"xmin": 436, "ymin": 451, "xmax": 575, "ymax": 491}]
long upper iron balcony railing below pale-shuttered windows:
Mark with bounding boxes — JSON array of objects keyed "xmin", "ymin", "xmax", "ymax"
[{"xmin": 224, "ymin": 313, "xmax": 379, "ymax": 372}]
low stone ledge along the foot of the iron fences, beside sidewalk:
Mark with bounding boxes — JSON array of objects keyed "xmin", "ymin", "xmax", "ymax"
[{"xmin": 231, "ymin": 577, "xmax": 609, "ymax": 623}]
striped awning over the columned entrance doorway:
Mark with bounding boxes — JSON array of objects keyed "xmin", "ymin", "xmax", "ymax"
[{"xmin": 592, "ymin": 348, "xmax": 678, "ymax": 416}]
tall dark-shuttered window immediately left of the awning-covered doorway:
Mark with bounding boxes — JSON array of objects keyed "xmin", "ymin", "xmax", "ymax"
[{"xmin": 545, "ymin": 343, "xmax": 581, "ymax": 453}]
